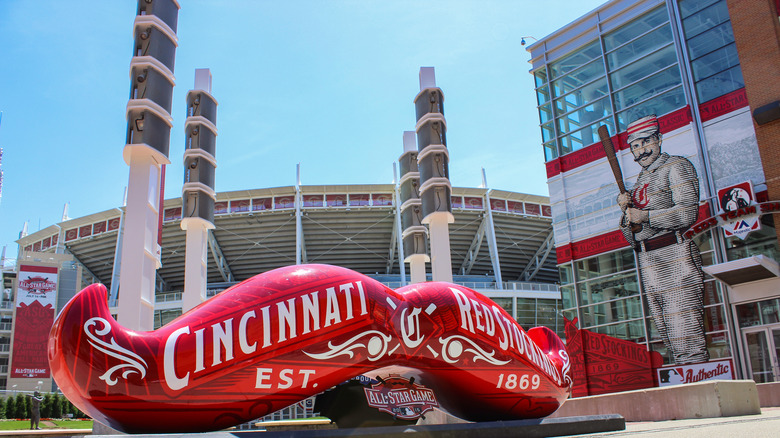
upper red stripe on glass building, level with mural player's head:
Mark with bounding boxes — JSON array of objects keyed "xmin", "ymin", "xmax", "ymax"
[{"xmin": 545, "ymin": 106, "xmax": 693, "ymax": 179}]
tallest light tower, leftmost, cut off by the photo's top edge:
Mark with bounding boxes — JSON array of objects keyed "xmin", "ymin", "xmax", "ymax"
[{"xmin": 117, "ymin": 0, "xmax": 179, "ymax": 330}]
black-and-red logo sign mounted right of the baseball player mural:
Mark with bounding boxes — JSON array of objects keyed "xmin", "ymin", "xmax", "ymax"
[{"xmin": 718, "ymin": 181, "xmax": 761, "ymax": 240}]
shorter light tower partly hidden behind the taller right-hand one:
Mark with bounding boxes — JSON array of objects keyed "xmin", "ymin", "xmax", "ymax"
[{"xmin": 398, "ymin": 131, "xmax": 430, "ymax": 283}]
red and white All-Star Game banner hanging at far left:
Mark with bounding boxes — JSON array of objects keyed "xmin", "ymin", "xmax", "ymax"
[{"xmin": 11, "ymin": 265, "xmax": 57, "ymax": 378}]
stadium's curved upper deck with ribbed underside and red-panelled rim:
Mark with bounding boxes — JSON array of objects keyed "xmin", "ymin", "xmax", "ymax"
[{"xmin": 18, "ymin": 184, "xmax": 558, "ymax": 291}]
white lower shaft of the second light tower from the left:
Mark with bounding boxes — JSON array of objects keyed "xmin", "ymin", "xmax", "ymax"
[{"xmin": 181, "ymin": 217, "xmax": 214, "ymax": 313}]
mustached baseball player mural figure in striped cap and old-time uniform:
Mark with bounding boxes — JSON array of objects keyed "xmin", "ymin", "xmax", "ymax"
[{"xmin": 617, "ymin": 115, "xmax": 709, "ymax": 364}]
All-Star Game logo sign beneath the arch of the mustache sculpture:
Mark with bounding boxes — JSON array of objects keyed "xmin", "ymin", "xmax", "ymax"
[{"xmin": 363, "ymin": 375, "xmax": 439, "ymax": 420}]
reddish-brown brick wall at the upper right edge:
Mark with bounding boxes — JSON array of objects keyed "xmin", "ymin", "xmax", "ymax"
[{"xmin": 726, "ymin": 0, "xmax": 780, "ymax": 239}]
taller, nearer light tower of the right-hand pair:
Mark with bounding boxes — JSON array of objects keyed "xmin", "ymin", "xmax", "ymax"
[{"xmin": 414, "ymin": 67, "xmax": 455, "ymax": 282}]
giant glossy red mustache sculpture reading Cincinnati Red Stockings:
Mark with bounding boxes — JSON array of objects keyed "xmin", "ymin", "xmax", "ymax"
[{"xmin": 49, "ymin": 265, "xmax": 571, "ymax": 433}]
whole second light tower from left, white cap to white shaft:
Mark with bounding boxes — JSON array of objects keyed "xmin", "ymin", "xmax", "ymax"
[{"xmin": 181, "ymin": 68, "xmax": 217, "ymax": 312}]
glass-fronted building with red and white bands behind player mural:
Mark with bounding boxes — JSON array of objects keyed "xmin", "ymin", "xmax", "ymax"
[{"xmin": 527, "ymin": 0, "xmax": 780, "ymax": 382}]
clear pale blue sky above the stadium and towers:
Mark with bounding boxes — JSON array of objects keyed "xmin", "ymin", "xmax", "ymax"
[{"xmin": 0, "ymin": 0, "xmax": 603, "ymax": 259}]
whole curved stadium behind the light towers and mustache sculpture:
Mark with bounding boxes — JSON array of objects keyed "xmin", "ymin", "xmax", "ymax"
[{"xmin": 7, "ymin": 180, "xmax": 563, "ymax": 389}]
